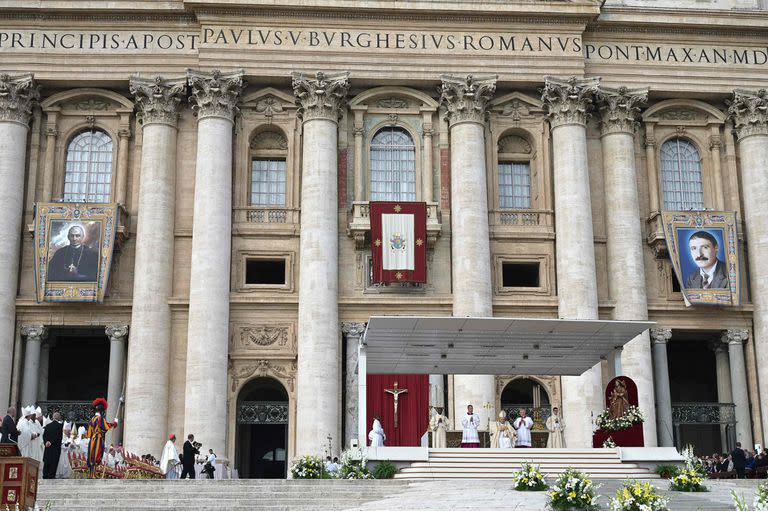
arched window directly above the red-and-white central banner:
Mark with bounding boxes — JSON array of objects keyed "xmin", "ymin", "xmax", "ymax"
[{"xmin": 371, "ymin": 127, "xmax": 416, "ymax": 201}]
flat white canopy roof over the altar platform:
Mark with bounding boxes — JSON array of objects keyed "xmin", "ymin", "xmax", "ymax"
[{"xmin": 361, "ymin": 316, "xmax": 655, "ymax": 376}]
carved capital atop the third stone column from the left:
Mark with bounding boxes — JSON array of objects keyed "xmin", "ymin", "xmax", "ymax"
[{"xmin": 187, "ymin": 69, "xmax": 245, "ymax": 121}]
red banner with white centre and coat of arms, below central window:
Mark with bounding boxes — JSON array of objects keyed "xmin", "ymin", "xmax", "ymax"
[{"xmin": 370, "ymin": 202, "xmax": 427, "ymax": 284}]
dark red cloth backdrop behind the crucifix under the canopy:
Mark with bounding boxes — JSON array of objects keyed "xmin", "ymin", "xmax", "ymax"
[{"xmin": 366, "ymin": 374, "xmax": 429, "ymax": 447}]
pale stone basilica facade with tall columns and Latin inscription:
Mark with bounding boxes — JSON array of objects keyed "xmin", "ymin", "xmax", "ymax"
[{"xmin": 0, "ymin": 0, "xmax": 768, "ymax": 466}]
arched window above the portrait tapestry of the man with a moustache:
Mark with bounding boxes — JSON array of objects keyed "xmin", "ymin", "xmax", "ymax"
[{"xmin": 661, "ymin": 138, "xmax": 704, "ymax": 211}]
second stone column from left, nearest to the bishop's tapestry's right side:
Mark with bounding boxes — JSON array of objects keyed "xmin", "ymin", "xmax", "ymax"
[{"xmin": 125, "ymin": 77, "xmax": 186, "ymax": 453}]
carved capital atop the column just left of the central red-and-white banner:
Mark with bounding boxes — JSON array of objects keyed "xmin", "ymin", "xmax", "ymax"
[{"xmin": 291, "ymin": 72, "xmax": 349, "ymax": 122}]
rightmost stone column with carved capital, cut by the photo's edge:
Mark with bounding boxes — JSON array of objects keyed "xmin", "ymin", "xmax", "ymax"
[{"xmin": 728, "ymin": 89, "xmax": 768, "ymax": 438}]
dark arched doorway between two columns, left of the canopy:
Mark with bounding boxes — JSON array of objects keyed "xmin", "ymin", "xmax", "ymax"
[{"xmin": 235, "ymin": 378, "xmax": 288, "ymax": 479}]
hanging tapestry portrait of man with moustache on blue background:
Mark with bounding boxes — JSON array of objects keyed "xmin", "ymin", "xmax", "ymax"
[{"xmin": 662, "ymin": 211, "xmax": 741, "ymax": 305}]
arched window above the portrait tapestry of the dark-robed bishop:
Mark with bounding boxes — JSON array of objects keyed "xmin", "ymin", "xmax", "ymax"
[{"xmin": 64, "ymin": 130, "xmax": 112, "ymax": 202}]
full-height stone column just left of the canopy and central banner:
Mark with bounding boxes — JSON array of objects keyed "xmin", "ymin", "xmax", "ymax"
[{"xmin": 293, "ymin": 73, "xmax": 349, "ymax": 456}]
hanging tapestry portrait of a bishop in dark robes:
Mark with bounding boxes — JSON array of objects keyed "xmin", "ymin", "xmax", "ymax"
[{"xmin": 34, "ymin": 202, "xmax": 119, "ymax": 302}]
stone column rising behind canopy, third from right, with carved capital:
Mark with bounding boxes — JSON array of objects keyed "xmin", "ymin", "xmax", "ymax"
[{"xmin": 542, "ymin": 77, "xmax": 604, "ymax": 448}]
